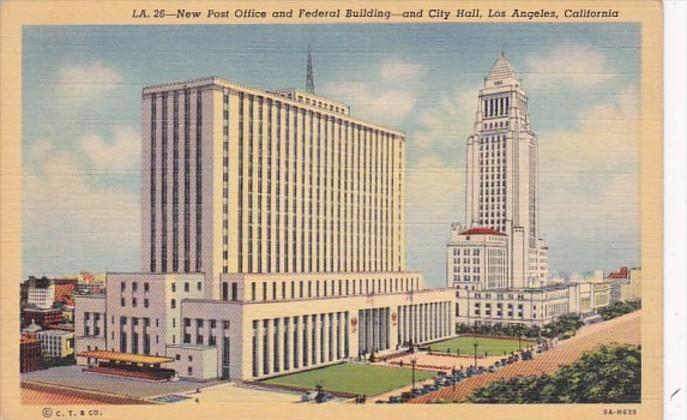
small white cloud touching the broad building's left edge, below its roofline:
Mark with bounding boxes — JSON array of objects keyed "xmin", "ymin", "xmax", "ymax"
[{"xmin": 80, "ymin": 126, "xmax": 141, "ymax": 171}]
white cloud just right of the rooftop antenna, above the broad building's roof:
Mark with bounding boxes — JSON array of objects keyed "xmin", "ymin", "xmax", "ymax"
[{"xmin": 323, "ymin": 82, "xmax": 416, "ymax": 123}]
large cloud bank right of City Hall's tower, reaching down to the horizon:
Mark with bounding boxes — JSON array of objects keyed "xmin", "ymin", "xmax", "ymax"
[{"xmin": 539, "ymin": 89, "xmax": 639, "ymax": 270}]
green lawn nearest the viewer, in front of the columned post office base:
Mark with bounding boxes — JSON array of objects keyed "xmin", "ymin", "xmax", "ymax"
[{"xmin": 263, "ymin": 363, "xmax": 434, "ymax": 396}]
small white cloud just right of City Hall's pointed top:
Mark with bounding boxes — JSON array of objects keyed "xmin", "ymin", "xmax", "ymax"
[{"xmin": 526, "ymin": 44, "xmax": 613, "ymax": 88}]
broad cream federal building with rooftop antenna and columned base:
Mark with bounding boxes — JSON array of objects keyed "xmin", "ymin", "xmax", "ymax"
[{"xmin": 75, "ymin": 55, "xmax": 455, "ymax": 380}]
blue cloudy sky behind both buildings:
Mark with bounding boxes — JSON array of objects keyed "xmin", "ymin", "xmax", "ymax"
[{"xmin": 22, "ymin": 24, "xmax": 640, "ymax": 286}]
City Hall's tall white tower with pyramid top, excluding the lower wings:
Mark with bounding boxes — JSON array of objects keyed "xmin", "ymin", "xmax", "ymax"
[{"xmin": 465, "ymin": 53, "xmax": 548, "ymax": 288}]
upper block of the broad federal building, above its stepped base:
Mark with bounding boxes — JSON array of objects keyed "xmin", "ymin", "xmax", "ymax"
[{"xmin": 141, "ymin": 78, "xmax": 405, "ymax": 299}]
